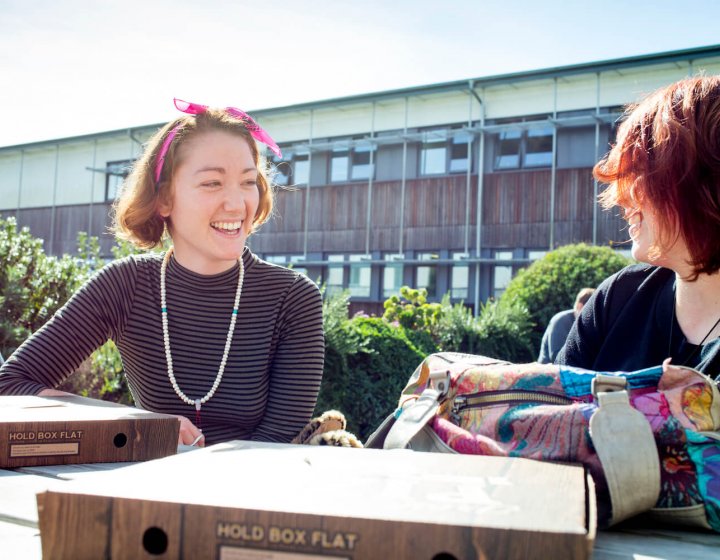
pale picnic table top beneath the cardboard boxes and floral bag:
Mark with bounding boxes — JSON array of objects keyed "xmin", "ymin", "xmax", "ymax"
[{"xmin": 0, "ymin": 448, "xmax": 720, "ymax": 560}]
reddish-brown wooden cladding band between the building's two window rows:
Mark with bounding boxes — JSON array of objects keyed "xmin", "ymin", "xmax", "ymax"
[{"xmin": 4, "ymin": 168, "xmax": 627, "ymax": 254}]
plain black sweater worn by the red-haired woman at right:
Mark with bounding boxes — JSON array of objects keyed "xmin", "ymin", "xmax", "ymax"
[{"xmin": 555, "ymin": 265, "xmax": 720, "ymax": 379}]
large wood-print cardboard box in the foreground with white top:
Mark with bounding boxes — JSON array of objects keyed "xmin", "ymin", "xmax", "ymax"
[{"xmin": 38, "ymin": 441, "xmax": 595, "ymax": 560}]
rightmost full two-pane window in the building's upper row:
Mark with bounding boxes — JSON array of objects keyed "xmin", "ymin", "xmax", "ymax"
[{"xmin": 495, "ymin": 127, "xmax": 553, "ymax": 170}]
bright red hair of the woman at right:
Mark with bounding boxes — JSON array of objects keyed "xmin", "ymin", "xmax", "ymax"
[{"xmin": 593, "ymin": 76, "xmax": 720, "ymax": 280}]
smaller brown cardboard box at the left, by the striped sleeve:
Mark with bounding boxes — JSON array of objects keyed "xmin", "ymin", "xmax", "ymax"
[{"xmin": 0, "ymin": 396, "xmax": 180, "ymax": 468}]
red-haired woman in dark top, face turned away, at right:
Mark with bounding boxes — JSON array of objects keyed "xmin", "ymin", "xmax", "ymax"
[{"xmin": 555, "ymin": 76, "xmax": 720, "ymax": 379}]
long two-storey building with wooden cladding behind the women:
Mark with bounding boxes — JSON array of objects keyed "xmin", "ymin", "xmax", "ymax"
[{"xmin": 0, "ymin": 45, "xmax": 720, "ymax": 312}]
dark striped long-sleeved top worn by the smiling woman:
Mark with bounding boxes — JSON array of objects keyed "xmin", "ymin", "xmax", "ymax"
[{"xmin": 0, "ymin": 248, "xmax": 324, "ymax": 444}]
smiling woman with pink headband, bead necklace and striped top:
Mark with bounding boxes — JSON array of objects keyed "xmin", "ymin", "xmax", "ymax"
[{"xmin": 0, "ymin": 100, "xmax": 324, "ymax": 445}]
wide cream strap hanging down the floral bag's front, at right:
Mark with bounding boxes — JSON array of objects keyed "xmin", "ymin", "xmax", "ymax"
[{"xmin": 590, "ymin": 374, "xmax": 660, "ymax": 525}]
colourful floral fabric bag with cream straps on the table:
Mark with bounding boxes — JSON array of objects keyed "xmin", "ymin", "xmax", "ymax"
[{"xmin": 366, "ymin": 353, "xmax": 720, "ymax": 532}]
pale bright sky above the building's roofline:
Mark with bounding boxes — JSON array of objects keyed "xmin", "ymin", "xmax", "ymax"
[{"xmin": 0, "ymin": 0, "xmax": 720, "ymax": 146}]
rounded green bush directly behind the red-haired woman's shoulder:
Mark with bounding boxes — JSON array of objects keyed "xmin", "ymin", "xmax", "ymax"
[{"xmin": 500, "ymin": 243, "xmax": 632, "ymax": 355}]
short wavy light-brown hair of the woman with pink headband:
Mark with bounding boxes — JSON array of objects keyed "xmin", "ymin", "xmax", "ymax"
[{"xmin": 112, "ymin": 109, "xmax": 273, "ymax": 249}]
